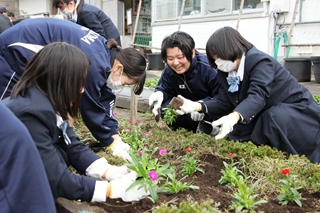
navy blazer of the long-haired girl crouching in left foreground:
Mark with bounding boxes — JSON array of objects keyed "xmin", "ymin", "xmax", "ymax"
[{"xmin": 2, "ymin": 87, "xmax": 99, "ymax": 202}]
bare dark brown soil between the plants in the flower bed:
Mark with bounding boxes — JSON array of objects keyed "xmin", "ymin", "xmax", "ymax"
[{"xmin": 79, "ymin": 109, "xmax": 320, "ymax": 213}]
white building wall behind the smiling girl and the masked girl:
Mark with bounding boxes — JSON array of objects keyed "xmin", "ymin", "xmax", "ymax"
[{"xmin": 152, "ymin": 0, "xmax": 320, "ymax": 60}]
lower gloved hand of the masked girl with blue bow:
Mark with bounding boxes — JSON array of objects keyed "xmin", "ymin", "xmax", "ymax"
[{"xmin": 212, "ymin": 112, "xmax": 240, "ymax": 140}]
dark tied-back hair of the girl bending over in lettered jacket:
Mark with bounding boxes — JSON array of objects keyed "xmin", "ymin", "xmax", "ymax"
[{"xmin": 107, "ymin": 39, "xmax": 147, "ymax": 95}]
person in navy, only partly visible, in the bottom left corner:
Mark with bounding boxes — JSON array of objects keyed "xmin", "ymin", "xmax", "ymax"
[{"xmin": 0, "ymin": 102, "xmax": 56, "ymax": 213}]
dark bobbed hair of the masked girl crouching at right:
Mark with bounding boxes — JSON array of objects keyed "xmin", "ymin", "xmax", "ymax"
[{"xmin": 206, "ymin": 27, "xmax": 253, "ymax": 67}]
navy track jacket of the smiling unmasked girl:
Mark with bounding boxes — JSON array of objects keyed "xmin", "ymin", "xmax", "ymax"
[{"xmin": 155, "ymin": 52, "xmax": 220, "ymax": 103}]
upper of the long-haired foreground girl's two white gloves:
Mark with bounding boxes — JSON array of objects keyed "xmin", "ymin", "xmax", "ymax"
[{"xmin": 86, "ymin": 158, "xmax": 130, "ymax": 181}]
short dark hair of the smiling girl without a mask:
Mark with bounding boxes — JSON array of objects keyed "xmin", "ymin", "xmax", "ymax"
[{"xmin": 161, "ymin": 31, "xmax": 195, "ymax": 62}]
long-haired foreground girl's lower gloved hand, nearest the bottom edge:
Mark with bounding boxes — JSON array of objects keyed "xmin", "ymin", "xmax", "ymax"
[{"xmin": 109, "ymin": 171, "xmax": 150, "ymax": 202}]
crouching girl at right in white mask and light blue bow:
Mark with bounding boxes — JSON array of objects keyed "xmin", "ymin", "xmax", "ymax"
[{"xmin": 174, "ymin": 27, "xmax": 320, "ymax": 163}]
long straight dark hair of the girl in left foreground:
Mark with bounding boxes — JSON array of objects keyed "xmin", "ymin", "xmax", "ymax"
[{"xmin": 10, "ymin": 42, "xmax": 90, "ymax": 120}]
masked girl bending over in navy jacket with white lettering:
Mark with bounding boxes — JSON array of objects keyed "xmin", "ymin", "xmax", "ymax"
[{"xmin": 0, "ymin": 18, "xmax": 146, "ymax": 160}]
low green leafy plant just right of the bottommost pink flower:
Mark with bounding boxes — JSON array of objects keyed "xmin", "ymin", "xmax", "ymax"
[{"xmin": 161, "ymin": 172, "xmax": 199, "ymax": 194}]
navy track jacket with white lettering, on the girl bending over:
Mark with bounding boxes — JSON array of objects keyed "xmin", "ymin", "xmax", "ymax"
[{"xmin": 0, "ymin": 18, "xmax": 118, "ymax": 146}]
